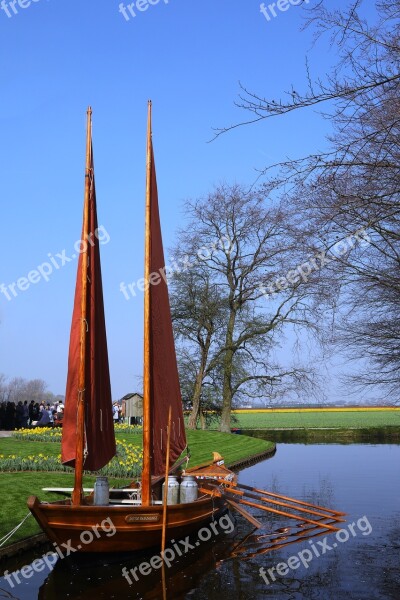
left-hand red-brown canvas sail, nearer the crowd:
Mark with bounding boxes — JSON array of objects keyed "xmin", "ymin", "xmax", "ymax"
[{"xmin": 61, "ymin": 111, "xmax": 116, "ymax": 471}]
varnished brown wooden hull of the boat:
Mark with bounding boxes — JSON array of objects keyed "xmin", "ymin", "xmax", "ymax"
[{"xmin": 28, "ymin": 496, "xmax": 227, "ymax": 556}]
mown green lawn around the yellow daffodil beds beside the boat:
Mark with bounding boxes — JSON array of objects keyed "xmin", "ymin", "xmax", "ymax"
[{"xmin": 0, "ymin": 431, "xmax": 274, "ymax": 543}]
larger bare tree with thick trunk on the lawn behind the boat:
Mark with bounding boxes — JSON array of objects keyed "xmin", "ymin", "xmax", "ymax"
[{"xmin": 173, "ymin": 185, "xmax": 320, "ymax": 432}]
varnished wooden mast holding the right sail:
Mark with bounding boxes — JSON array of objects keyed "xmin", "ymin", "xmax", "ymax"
[{"xmin": 142, "ymin": 100, "xmax": 153, "ymax": 506}]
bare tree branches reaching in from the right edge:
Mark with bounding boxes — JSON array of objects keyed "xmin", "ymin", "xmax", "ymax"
[{"xmin": 217, "ymin": 0, "xmax": 400, "ymax": 401}]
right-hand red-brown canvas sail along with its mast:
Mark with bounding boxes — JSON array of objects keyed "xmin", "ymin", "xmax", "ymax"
[{"xmin": 144, "ymin": 101, "xmax": 186, "ymax": 482}]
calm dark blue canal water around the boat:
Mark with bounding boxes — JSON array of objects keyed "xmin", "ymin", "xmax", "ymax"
[{"xmin": 0, "ymin": 444, "xmax": 400, "ymax": 600}]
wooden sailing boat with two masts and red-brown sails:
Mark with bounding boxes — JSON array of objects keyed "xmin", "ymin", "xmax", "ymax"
[{"xmin": 28, "ymin": 102, "xmax": 233, "ymax": 552}]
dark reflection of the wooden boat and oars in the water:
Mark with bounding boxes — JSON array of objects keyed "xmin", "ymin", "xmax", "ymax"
[{"xmin": 38, "ymin": 506, "xmax": 346, "ymax": 600}]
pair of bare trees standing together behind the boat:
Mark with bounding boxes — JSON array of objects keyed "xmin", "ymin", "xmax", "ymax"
[{"xmin": 172, "ymin": 185, "xmax": 324, "ymax": 431}]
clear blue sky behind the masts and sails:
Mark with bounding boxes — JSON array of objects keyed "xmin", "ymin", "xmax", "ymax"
[{"xmin": 0, "ymin": 0, "xmax": 376, "ymax": 398}]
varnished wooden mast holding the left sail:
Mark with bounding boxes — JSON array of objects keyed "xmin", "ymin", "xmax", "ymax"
[{"xmin": 71, "ymin": 106, "xmax": 92, "ymax": 505}]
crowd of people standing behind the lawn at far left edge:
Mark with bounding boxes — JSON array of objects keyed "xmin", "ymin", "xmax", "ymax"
[{"xmin": 0, "ymin": 400, "xmax": 64, "ymax": 431}]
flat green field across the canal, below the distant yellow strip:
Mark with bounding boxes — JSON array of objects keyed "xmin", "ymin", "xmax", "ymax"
[{"xmin": 228, "ymin": 409, "xmax": 400, "ymax": 429}]
